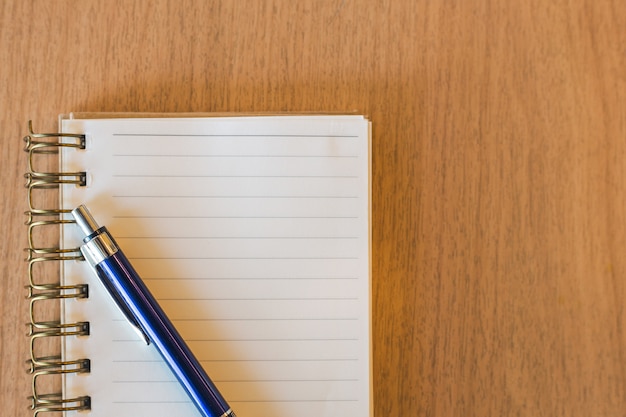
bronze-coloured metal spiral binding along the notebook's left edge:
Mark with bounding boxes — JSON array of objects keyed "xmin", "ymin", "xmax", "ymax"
[{"xmin": 24, "ymin": 121, "xmax": 91, "ymax": 416}]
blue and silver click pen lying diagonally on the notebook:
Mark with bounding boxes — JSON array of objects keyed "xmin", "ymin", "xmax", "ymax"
[{"xmin": 72, "ymin": 205, "xmax": 236, "ymax": 417}]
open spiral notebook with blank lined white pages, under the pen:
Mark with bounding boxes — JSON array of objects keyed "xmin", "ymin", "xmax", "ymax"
[{"xmin": 27, "ymin": 114, "xmax": 372, "ymax": 417}]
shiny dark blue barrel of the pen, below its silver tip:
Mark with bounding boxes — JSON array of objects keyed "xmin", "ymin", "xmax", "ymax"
[{"xmin": 95, "ymin": 250, "xmax": 235, "ymax": 417}]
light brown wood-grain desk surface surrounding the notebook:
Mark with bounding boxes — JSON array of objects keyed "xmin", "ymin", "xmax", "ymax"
[{"xmin": 0, "ymin": 0, "xmax": 626, "ymax": 417}]
